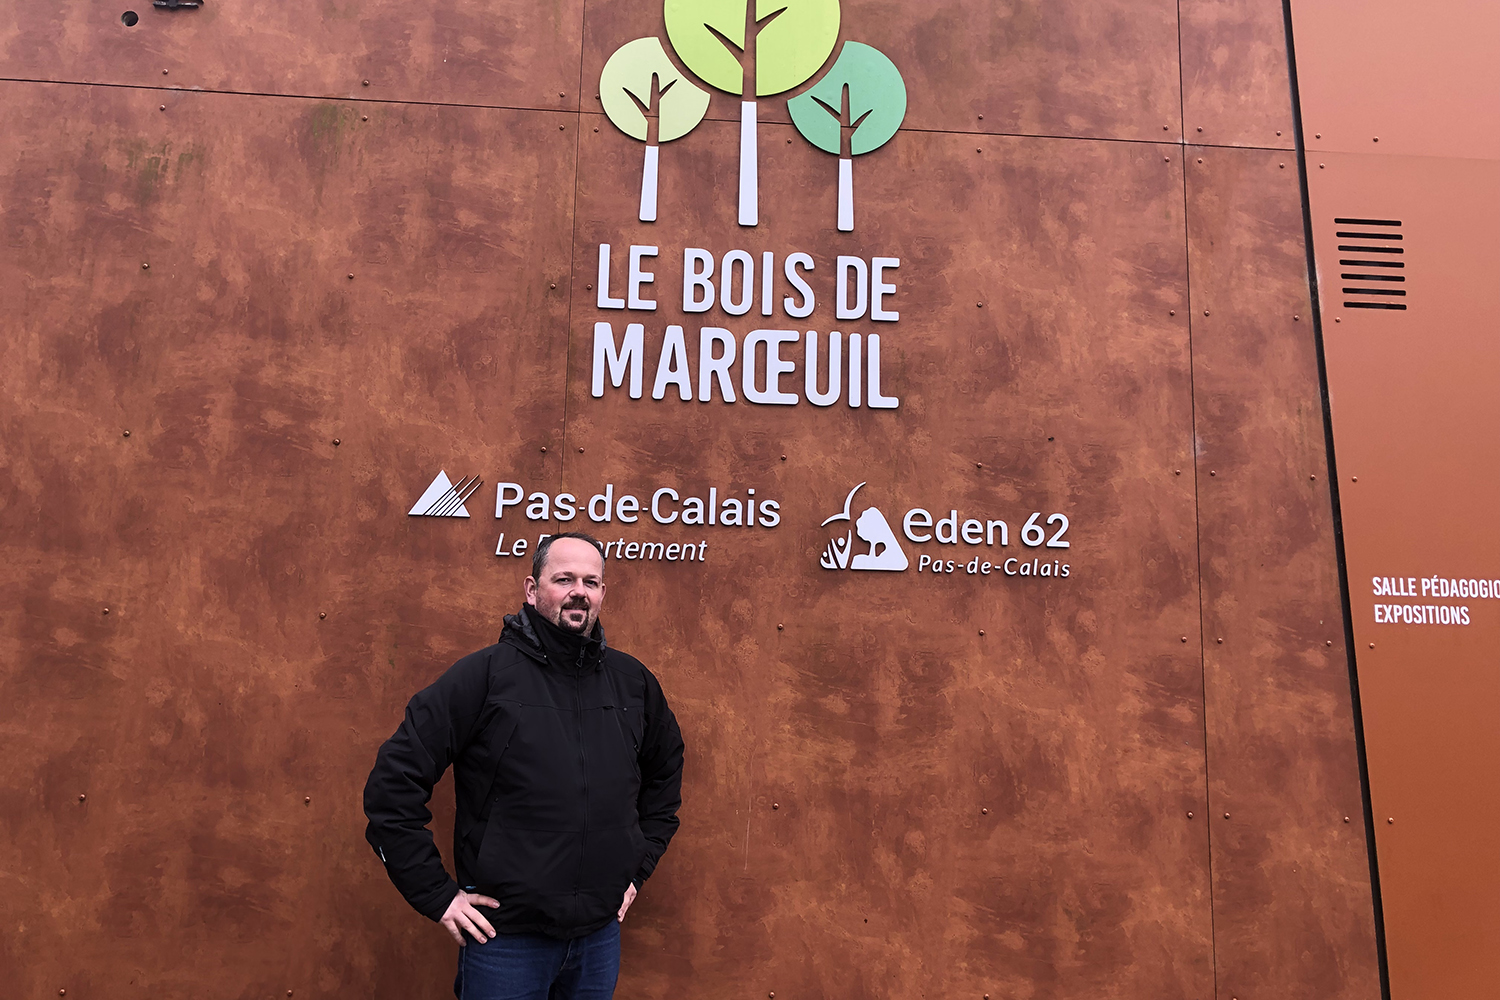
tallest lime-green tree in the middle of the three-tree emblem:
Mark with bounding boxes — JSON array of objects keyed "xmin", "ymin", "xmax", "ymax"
[{"xmin": 663, "ymin": 0, "xmax": 839, "ymax": 226}]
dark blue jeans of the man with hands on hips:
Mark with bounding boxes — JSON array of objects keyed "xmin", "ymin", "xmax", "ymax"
[{"xmin": 453, "ymin": 921, "xmax": 620, "ymax": 1000}]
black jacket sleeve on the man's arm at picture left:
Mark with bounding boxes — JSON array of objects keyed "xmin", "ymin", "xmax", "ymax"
[{"xmin": 365, "ymin": 654, "xmax": 489, "ymax": 921}]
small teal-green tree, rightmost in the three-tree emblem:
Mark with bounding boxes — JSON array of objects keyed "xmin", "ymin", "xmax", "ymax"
[{"xmin": 786, "ymin": 42, "xmax": 906, "ymax": 232}]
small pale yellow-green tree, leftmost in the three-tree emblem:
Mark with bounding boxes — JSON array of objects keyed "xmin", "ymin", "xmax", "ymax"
[{"xmin": 599, "ymin": 37, "xmax": 708, "ymax": 222}]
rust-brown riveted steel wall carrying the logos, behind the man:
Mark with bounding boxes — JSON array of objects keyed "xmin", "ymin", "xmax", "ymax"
[{"xmin": 0, "ymin": 0, "xmax": 1380, "ymax": 1000}]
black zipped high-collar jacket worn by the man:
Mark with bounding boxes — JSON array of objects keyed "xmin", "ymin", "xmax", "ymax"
[{"xmin": 365, "ymin": 606, "xmax": 683, "ymax": 939}]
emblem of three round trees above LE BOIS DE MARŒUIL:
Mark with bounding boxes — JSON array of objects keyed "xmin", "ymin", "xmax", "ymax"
[{"xmin": 599, "ymin": 0, "xmax": 906, "ymax": 232}]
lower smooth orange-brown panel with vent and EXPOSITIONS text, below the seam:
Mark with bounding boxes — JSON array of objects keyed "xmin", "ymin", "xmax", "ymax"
[{"xmin": 1310, "ymin": 153, "xmax": 1500, "ymax": 1000}]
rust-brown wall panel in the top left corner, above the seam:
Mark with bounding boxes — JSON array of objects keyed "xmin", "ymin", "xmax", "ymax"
[{"xmin": 0, "ymin": 0, "xmax": 585, "ymax": 109}]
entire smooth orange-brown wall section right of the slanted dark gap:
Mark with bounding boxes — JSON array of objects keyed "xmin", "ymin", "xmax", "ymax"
[{"xmin": 1292, "ymin": 0, "xmax": 1500, "ymax": 1000}]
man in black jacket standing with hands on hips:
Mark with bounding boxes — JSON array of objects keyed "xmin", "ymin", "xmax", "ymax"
[{"xmin": 365, "ymin": 532, "xmax": 683, "ymax": 1000}]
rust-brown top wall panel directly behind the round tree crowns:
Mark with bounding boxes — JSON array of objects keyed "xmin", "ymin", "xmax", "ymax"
[{"xmin": 584, "ymin": 0, "xmax": 1182, "ymax": 141}]
